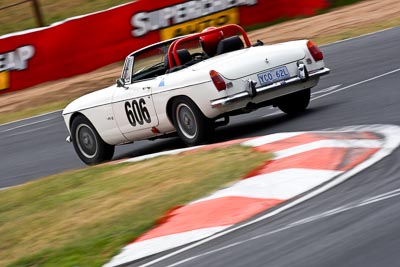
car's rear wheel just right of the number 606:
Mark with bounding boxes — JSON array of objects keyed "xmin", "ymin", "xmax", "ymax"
[{"xmin": 172, "ymin": 97, "xmax": 214, "ymax": 146}]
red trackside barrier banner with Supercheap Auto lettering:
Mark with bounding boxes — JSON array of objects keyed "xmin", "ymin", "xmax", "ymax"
[{"xmin": 0, "ymin": 0, "xmax": 328, "ymax": 94}]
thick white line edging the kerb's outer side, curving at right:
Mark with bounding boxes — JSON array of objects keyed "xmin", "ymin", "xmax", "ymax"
[{"xmin": 134, "ymin": 125, "xmax": 400, "ymax": 267}]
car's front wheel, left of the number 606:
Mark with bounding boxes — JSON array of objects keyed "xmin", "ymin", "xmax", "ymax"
[{"xmin": 71, "ymin": 115, "xmax": 114, "ymax": 165}]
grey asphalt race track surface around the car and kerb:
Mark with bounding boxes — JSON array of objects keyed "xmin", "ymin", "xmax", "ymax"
[{"xmin": 0, "ymin": 28, "xmax": 400, "ymax": 266}]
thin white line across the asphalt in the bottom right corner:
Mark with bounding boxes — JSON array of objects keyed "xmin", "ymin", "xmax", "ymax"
[{"xmin": 166, "ymin": 189, "xmax": 400, "ymax": 267}]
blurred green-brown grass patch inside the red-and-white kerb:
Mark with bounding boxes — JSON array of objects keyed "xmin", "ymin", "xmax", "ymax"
[{"xmin": 0, "ymin": 146, "xmax": 270, "ymax": 267}]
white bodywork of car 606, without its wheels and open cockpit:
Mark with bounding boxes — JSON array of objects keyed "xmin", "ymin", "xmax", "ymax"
[{"xmin": 63, "ymin": 25, "xmax": 329, "ymax": 164}]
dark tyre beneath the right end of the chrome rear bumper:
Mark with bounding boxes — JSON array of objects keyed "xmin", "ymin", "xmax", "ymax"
[{"xmin": 277, "ymin": 89, "xmax": 311, "ymax": 115}]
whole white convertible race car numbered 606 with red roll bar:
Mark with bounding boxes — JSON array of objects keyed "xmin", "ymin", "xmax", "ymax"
[{"xmin": 63, "ymin": 25, "xmax": 329, "ymax": 164}]
